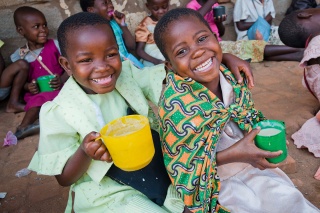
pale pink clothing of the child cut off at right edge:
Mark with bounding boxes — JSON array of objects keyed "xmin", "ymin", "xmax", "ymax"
[{"xmin": 291, "ymin": 36, "xmax": 320, "ymax": 157}]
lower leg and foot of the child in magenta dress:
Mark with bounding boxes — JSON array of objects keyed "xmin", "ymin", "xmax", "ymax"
[{"xmin": 14, "ymin": 107, "xmax": 41, "ymax": 139}]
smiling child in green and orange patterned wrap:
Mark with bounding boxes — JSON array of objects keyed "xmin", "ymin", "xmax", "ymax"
[{"xmin": 155, "ymin": 8, "xmax": 319, "ymax": 212}]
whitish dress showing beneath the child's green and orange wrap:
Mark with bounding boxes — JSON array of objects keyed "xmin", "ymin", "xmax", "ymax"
[{"xmin": 217, "ymin": 72, "xmax": 320, "ymax": 213}]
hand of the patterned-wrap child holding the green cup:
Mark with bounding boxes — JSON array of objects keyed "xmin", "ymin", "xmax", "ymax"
[{"xmin": 232, "ymin": 128, "xmax": 282, "ymax": 170}]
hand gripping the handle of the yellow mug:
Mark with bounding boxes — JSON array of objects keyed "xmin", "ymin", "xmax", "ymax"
[{"xmin": 81, "ymin": 132, "xmax": 112, "ymax": 163}]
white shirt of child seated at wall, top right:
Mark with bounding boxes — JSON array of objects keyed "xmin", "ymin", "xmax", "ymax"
[{"xmin": 233, "ymin": 0, "xmax": 276, "ymax": 40}]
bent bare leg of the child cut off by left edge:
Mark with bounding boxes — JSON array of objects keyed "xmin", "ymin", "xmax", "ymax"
[{"xmin": 0, "ymin": 59, "xmax": 29, "ymax": 112}]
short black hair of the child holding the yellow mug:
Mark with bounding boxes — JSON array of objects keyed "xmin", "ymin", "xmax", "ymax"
[{"xmin": 57, "ymin": 12, "xmax": 113, "ymax": 57}]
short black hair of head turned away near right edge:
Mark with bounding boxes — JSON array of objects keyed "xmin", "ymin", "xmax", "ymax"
[{"xmin": 278, "ymin": 10, "xmax": 311, "ymax": 48}]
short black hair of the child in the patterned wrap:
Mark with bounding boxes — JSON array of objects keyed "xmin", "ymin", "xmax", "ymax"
[{"xmin": 153, "ymin": 8, "xmax": 211, "ymax": 60}]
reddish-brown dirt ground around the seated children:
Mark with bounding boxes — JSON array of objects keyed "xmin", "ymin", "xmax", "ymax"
[{"xmin": 0, "ymin": 62, "xmax": 320, "ymax": 212}]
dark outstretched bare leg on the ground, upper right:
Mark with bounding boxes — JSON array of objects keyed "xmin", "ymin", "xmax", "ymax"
[{"xmin": 264, "ymin": 45, "xmax": 304, "ymax": 61}]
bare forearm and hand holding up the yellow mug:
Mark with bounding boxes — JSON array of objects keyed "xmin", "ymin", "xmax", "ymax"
[{"xmin": 55, "ymin": 132, "xmax": 112, "ymax": 186}]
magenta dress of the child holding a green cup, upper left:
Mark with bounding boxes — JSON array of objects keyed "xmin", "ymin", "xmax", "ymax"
[{"xmin": 24, "ymin": 39, "xmax": 64, "ymax": 111}]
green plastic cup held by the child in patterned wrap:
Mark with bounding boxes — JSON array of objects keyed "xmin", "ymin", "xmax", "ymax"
[{"xmin": 253, "ymin": 120, "xmax": 288, "ymax": 163}]
